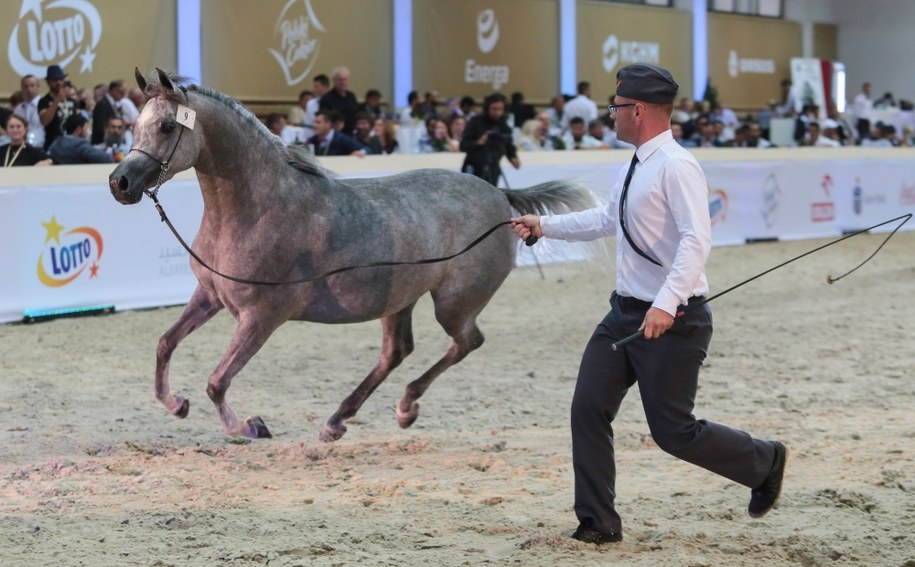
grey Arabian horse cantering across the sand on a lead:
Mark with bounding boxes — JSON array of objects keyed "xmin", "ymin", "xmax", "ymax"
[{"xmin": 109, "ymin": 69, "xmax": 590, "ymax": 441}]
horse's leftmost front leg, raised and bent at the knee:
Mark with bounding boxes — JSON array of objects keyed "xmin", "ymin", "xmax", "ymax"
[{"xmin": 155, "ymin": 285, "xmax": 222, "ymax": 418}]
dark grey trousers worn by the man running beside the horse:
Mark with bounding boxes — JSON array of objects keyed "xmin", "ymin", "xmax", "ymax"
[{"xmin": 572, "ymin": 292, "xmax": 775, "ymax": 532}]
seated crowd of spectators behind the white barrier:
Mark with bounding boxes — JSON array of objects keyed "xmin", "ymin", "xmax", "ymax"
[{"xmin": 0, "ymin": 65, "xmax": 915, "ymax": 167}]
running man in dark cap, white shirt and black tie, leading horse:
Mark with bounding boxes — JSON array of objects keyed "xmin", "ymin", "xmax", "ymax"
[{"xmin": 512, "ymin": 64, "xmax": 787, "ymax": 544}]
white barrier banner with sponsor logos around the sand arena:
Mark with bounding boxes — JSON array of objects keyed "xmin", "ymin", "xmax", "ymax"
[{"xmin": 0, "ymin": 154, "xmax": 915, "ymax": 322}]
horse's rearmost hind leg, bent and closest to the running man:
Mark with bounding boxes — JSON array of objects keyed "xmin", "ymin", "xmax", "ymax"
[{"xmin": 397, "ymin": 304, "xmax": 483, "ymax": 429}]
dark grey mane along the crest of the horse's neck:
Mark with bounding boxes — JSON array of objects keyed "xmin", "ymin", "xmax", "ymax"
[{"xmin": 145, "ymin": 74, "xmax": 331, "ymax": 179}]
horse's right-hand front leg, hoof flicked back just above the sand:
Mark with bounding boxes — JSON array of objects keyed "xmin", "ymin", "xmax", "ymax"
[{"xmin": 207, "ymin": 315, "xmax": 282, "ymax": 439}]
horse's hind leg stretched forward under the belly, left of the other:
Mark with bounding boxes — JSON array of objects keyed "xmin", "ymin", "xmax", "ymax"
[{"xmin": 320, "ymin": 303, "xmax": 416, "ymax": 442}]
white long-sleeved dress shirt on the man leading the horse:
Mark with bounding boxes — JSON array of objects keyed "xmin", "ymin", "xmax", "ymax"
[{"xmin": 540, "ymin": 130, "xmax": 712, "ymax": 316}]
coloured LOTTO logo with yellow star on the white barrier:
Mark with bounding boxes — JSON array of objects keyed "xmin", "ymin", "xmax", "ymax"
[{"xmin": 37, "ymin": 215, "xmax": 103, "ymax": 287}]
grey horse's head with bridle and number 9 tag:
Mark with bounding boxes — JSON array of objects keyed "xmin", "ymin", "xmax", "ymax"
[{"xmin": 108, "ymin": 68, "xmax": 200, "ymax": 205}]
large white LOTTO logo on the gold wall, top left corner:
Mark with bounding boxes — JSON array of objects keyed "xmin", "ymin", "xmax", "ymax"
[{"xmin": 5, "ymin": 0, "xmax": 102, "ymax": 77}]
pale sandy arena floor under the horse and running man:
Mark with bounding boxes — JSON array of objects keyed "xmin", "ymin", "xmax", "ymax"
[{"xmin": 0, "ymin": 232, "xmax": 915, "ymax": 567}]
